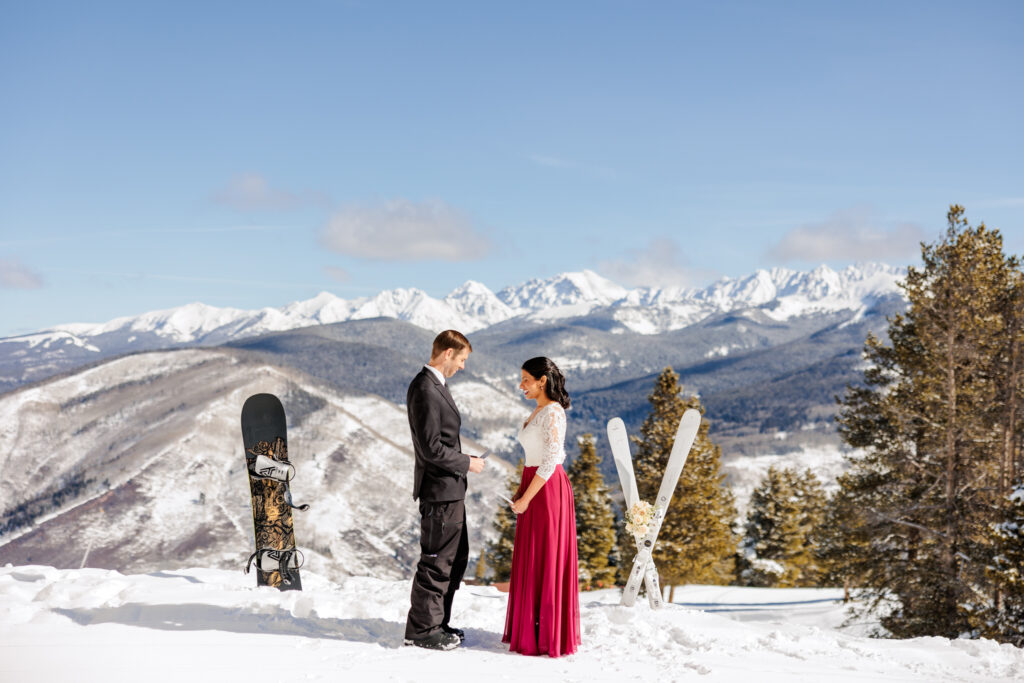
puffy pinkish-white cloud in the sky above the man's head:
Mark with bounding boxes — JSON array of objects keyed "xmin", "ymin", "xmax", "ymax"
[{"xmin": 321, "ymin": 200, "xmax": 490, "ymax": 261}]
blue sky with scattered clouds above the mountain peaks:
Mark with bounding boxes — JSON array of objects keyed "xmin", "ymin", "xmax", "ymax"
[{"xmin": 0, "ymin": 0, "xmax": 1024, "ymax": 335}]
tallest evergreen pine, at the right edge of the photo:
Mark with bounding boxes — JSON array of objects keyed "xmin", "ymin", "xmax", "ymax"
[{"xmin": 839, "ymin": 206, "xmax": 1020, "ymax": 637}]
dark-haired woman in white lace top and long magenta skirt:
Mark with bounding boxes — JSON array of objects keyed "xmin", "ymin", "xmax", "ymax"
[{"xmin": 502, "ymin": 357, "xmax": 581, "ymax": 657}]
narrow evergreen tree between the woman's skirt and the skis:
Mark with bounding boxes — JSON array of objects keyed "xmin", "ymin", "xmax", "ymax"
[{"xmin": 566, "ymin": 434, "xmax": 615, "ymax": 590}]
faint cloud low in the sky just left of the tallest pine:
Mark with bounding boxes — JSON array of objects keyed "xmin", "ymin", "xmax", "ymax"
[{"xmin": 767, "ymin": 209, "xmax": 927, "ymax": 261}]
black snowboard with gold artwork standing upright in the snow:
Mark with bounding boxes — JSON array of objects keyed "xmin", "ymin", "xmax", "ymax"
[{"xmin": 242, "ymin": 393, "xmax": 308, "ymax": 591}]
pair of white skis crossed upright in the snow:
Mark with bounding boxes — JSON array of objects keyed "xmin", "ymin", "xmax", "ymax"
[{"xmin": 608, "ymin": 409, "xmax": 700, "ymax": 609}]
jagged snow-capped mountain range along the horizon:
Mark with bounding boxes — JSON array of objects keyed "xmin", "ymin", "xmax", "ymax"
[{"xmin": 0, "ymin": 263, "xmax": 903, "ymax": 391}]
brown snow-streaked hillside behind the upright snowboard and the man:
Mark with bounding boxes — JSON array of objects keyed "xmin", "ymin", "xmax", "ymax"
[{"xmin": 0, "ymin": 349, "xmax": 511, "ymax": 579}]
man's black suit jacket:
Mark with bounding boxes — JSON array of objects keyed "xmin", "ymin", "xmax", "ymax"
[{"xmin": 406, "ymin": 368, "xmax": 469, "ymax": 503}]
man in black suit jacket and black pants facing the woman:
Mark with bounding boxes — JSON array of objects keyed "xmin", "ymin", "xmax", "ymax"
[{"xmin": 404, "ymin": 330, "xmax": 484, "ymax": 650}]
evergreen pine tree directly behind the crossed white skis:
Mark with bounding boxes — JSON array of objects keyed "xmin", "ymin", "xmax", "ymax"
[{"xmin": 623, "ymin": 368, "xmax": 736, "ymax": 600}]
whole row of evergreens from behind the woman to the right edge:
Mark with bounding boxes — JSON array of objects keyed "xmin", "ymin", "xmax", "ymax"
[{"xmin": 477, "ymin": 205, "xmax": 1024, "ymax": 646}]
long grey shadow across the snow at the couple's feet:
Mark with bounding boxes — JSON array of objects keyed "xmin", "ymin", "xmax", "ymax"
[{"xmin": 53, "ymin": 603, "xmax": 505, "ymax": 651}]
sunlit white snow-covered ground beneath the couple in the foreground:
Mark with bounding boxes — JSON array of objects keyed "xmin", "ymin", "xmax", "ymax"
[{"xmin": 0, "ymin": 565, "xmax": 1024, "ymax": 683}]
